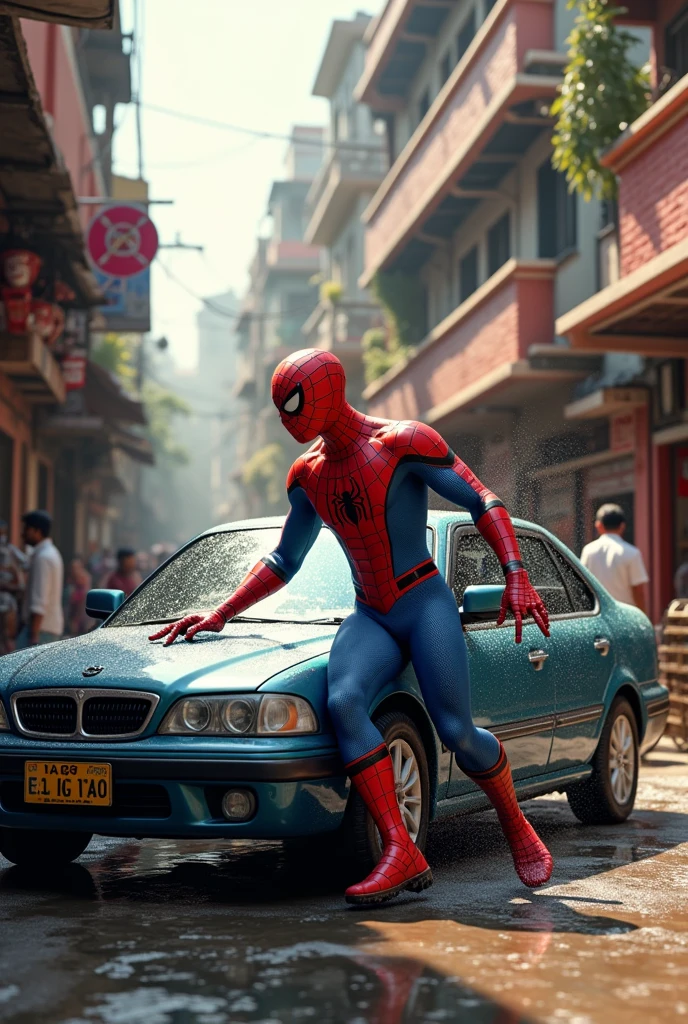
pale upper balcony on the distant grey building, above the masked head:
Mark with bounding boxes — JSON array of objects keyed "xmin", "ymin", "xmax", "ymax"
[{"xmin": 306, "ymin": 145, "xmax": 388, "ymax": 246}]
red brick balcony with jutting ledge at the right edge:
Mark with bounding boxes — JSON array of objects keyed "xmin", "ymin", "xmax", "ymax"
[{"xmin": 556, "ymin": 75, "xmax": 688, "ymax": 358}]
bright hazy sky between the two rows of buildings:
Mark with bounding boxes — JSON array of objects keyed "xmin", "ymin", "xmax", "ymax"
[{"xmin": 114, "ymin": 0, "xmax": 368, "ymax": 367}]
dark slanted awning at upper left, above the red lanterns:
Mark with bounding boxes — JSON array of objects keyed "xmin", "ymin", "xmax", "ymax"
[{"xmin": 0, "ymin": 17, "xmax": 104, "ymax": 306}]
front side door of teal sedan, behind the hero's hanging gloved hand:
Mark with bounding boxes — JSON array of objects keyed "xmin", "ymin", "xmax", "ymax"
[{"xmin": 448, "ymin": 526, "xmax": 571, "ymax": 796}]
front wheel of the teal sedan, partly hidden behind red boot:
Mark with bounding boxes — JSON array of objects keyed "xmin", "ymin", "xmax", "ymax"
[{"xmin": 344, "ymin": 711, "xmax": 430, "ymax": 873}]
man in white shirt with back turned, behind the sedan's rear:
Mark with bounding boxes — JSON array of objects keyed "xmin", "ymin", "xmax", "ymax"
[{"xmin": 581, "ymin": 505, "xmax": 649, "ymax": 614}]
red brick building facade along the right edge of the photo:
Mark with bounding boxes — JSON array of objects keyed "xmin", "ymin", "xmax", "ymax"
[{"xmin": 557, "ymin": 0, "xmax": 688, "ymax": 617}]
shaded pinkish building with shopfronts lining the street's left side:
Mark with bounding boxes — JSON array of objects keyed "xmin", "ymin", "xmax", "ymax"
[{"xmin": 0, "ymin": 3, "xmax": 152, "ymax": 557}]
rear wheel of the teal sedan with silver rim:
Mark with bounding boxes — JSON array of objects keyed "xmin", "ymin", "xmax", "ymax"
[{"xmin": 566, "ymin": 697, "xmax": 640, "ymax": 825}]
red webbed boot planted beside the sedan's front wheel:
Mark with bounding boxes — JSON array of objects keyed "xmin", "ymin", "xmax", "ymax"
[{"xmin": 346, "ymin": 743, "xmax": 432, "ymax": 904}]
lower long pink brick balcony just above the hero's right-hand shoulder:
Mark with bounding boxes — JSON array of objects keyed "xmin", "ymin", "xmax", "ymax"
[{"xmin": 364, "ymin": 259, "xmax": 556, "ymax": 423}]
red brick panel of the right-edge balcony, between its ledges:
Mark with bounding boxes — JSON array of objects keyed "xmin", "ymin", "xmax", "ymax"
[{"xmin": 619, "ymin": 116, "xmax": 688, "ymax": 275}]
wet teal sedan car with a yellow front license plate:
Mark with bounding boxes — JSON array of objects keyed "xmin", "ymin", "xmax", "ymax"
[{"xmin": 0, "ymin": 512, "xmax": 669, "ymax": 867}]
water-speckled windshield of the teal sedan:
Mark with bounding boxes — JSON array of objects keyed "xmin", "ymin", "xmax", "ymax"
[{"xmin": 108, "ymin": 528, "xmax": 354, "ymax": 626}]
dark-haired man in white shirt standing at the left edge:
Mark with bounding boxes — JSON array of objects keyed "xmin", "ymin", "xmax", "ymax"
[{"xmin": 16, "ymin": 510, "xmax": 65, "ymax": 648}]
